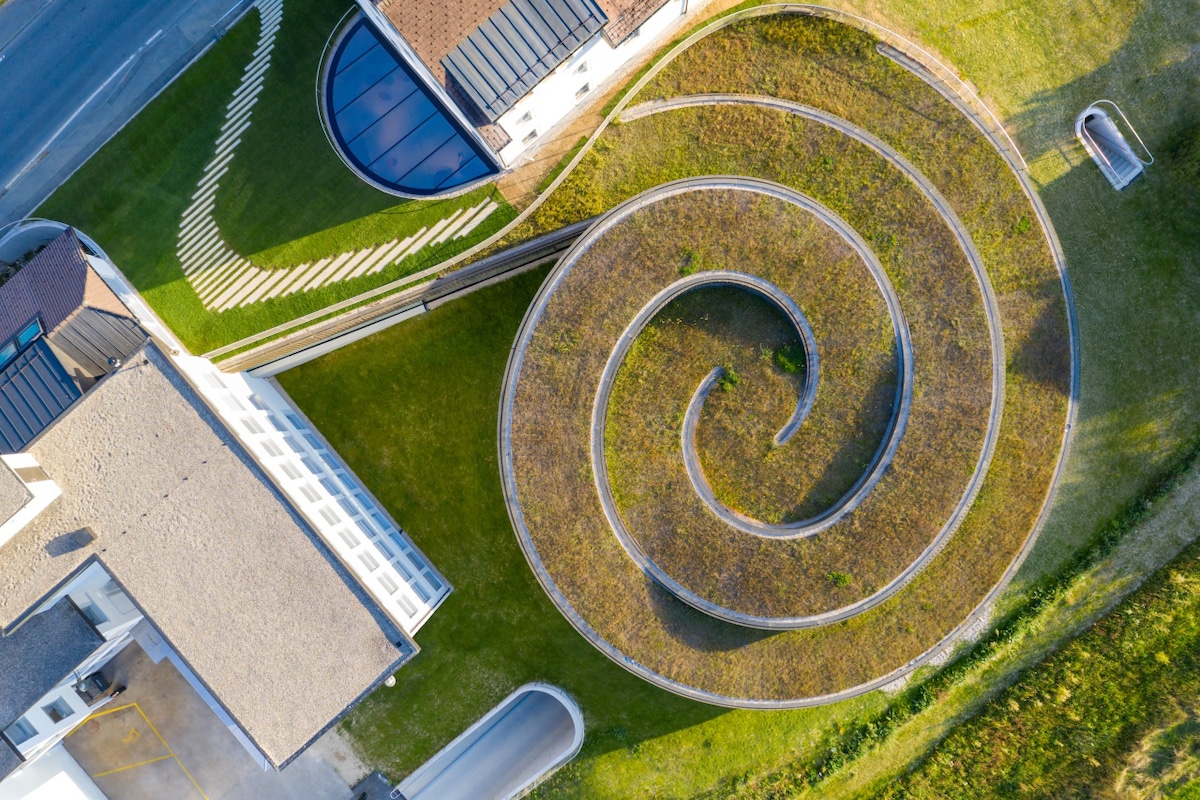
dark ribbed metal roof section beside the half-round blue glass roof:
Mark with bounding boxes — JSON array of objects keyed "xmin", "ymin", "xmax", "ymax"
[{"xmin": 442, "ymin": 0, "xmax": 607, "ymax": 122}]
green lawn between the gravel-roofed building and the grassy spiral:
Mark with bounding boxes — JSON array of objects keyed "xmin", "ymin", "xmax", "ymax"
[{"xmin": 280, "ymin": 270, "xmax": 883, "ymax": 798}]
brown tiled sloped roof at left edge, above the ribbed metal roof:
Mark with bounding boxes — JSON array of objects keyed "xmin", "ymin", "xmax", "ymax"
[{"xmin": 0, "ymin": 228, "xmax": 130, "ymax": 344}]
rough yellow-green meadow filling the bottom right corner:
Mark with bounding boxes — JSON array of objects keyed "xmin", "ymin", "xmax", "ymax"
[{"xmin": 877, "ymin": 532, "xmax": 1200, "ymax": 800}]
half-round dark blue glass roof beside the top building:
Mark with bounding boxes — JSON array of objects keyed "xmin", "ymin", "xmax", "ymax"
[{"xmin": 325, "ymin": 19, "xmax": 499, "ymax": 196}]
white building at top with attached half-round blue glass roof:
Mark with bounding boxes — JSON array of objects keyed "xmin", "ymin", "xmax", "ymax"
[{"xmin": 322, "ymin": 0, "xmax": 688, "ymax": 197}]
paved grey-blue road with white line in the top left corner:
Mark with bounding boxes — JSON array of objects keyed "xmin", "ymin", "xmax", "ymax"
[{"xmin": 0, "ymin": 0, "xmax": 248, "ymax": 224}]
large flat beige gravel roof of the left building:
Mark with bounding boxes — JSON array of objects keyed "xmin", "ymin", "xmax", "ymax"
[{"xmin": 0, "ymin": 343, "xmax": 412, "ymax": 766}]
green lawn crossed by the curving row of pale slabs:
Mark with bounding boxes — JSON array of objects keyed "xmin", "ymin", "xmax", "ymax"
[{"xmin": 37, "ymin": 0, "xmax": 515, "ymax": 353}]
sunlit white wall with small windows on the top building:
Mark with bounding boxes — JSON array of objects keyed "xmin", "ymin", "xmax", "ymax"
[{"xmin": 497, "ymin": 0, "xmax": 686, "ymax": 167}]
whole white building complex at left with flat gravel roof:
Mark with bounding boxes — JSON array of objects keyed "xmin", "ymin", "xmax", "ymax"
[{"xmin": 0, "ymin": 223, "xmax": 450, "ymax": 794}]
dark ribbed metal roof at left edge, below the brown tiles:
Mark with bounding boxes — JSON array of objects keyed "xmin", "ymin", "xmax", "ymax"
[{"xmin": 0, "ymin": 338, "xmax": 82, "ymax": 453}]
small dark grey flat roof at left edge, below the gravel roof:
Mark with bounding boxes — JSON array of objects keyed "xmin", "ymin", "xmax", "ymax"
[{"xmin": 0, "ymin": 597, "xmax": 104, "ymax": 729}]
